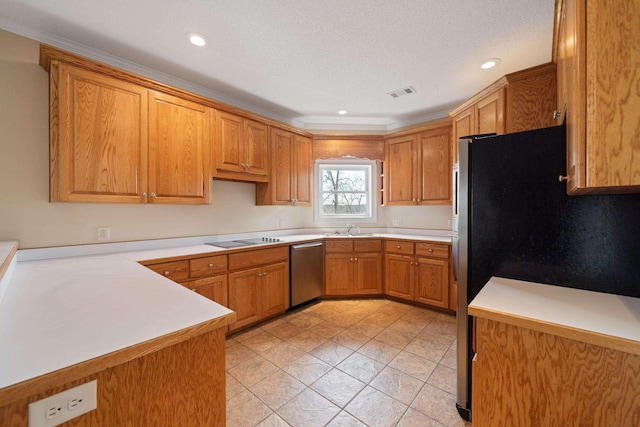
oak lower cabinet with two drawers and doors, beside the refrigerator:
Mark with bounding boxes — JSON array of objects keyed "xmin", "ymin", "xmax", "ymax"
[{"xmin": 385, "ymin": 240, "xmax": 451, "ymax": 309}]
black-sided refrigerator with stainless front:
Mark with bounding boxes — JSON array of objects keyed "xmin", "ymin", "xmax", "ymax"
[{"xmin": 452, "ymin": 126, "xmax": 640, "ymax": 420}]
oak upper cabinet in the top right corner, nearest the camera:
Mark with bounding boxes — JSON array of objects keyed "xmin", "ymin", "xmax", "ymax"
[{"xmin": 554, "ymin": 0, "xmax": 640, "ymax": 194}]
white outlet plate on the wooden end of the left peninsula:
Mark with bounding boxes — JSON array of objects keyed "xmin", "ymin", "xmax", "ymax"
[{"xmin": 29, "ymin": 380, "xmax": 98, "ymax": 427}]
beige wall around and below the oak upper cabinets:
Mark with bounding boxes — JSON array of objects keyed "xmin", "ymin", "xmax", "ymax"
[{"xmin": 0, "ymin": 30, "xmax": 451, "ymax": 248}]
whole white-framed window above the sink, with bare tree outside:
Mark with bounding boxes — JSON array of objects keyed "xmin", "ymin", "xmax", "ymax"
[{"xmin": 314, "ymin": 158, "xmax": 377, "ymax": 223}]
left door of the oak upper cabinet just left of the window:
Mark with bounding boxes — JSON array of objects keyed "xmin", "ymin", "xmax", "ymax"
[{"xmin": 270, "ymin": 128, "xmax": 294, "ymax": 205}]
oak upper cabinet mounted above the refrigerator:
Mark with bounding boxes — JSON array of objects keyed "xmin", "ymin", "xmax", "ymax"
[{"xmin": 449, "ymin": 63, "xmax": 556, "ymax": 164}]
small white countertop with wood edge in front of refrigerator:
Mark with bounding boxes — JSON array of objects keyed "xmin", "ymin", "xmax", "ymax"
[{"xmin": 469, "ymin": 277, "xmax": 640, "ymax": 343}]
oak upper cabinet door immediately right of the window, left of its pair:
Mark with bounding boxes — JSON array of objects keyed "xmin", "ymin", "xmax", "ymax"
[{"xmin": 384, "ymin": 135, "xmax": 417, "ymax": 206}]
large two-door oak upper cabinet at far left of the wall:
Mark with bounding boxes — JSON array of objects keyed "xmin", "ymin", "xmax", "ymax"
[{"xmin": 40, "ymin": 46, "xmax": 213, "ymax": 204}]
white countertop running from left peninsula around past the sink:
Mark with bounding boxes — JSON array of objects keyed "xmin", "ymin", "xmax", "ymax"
[{"xmin": 0, "ymin": 232, "xmax": 451, "ymax": 390}]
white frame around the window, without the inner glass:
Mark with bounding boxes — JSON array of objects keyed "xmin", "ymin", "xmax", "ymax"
[{"xmin": 313, "ymin": 157, "xmax": 378, "ymax": 225}]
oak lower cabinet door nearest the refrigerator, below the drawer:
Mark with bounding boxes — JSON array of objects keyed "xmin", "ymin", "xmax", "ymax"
[{"xmin": 415, "ymin": 258, "xmax": 449, "ymax": 308}]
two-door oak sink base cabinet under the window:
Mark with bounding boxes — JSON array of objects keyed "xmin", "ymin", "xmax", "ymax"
[{"xmin": 324, "ymin": 239, "xmax": 382, "ymax": 296}]
